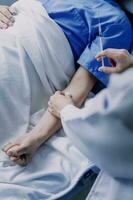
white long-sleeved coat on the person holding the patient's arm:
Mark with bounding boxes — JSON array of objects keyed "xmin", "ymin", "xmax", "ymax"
[{"xmin": 61, "ymin": 69, "xmax": 133, "ymax": 200}]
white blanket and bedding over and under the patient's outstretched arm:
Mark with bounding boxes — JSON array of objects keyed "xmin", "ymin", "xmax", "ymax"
[{"xmin": 0, "ymin": 0, "xmax": 93, "ymax": 200}]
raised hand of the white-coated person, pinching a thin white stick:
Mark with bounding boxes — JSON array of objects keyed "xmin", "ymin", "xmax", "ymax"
[{"xmin": 96, "ymin": 49, "xmax": 133, "ymax": 74}]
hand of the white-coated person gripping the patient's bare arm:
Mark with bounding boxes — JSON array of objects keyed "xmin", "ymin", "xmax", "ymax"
[{"xmin": 48, "ymin": 91, "xmax": 74, "ymax": 118}]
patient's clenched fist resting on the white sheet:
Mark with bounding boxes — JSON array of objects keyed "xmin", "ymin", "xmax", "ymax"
[{"xmin": 3, "ymin": 133, "xmax": 40, "ymax": 166}]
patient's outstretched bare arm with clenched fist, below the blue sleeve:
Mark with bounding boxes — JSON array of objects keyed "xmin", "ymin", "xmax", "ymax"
[{"xmin": 3, "ymin": 67, "xmax": 96, "ymax": 166}]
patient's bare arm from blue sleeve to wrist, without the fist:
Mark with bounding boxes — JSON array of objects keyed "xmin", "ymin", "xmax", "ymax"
[{"xmin": 32, "ymin": 67, "xmax": 96, "ymax": 144}]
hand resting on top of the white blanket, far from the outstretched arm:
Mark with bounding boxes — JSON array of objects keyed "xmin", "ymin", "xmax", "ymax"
[{"xmin": 0, "ymin": 6, "xmax": 17, "ymax": 29}]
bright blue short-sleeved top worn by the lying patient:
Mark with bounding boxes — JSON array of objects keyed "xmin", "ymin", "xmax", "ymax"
[{"xmin": 40, "ymin": 0, "xmax": 133, "ymax": 86}]
